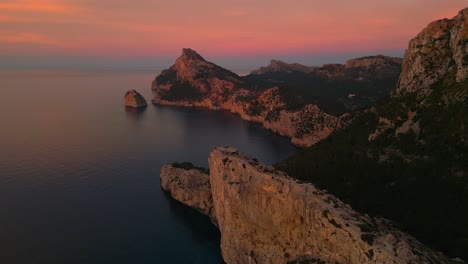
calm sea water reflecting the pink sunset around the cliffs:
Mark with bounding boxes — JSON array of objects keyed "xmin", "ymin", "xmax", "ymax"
[{"xmin": 0, "ymin": 71, "xmax": 296, "ymax": 263}]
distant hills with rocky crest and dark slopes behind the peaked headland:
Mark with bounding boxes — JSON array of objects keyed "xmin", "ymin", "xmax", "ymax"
[{"xmin": 242, "ymin": 55, "xmax": 402, "ymax": 115}]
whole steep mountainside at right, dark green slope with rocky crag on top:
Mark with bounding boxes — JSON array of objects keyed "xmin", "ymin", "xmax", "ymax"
[{"xmin": 277, "ymin": 9, "xmax": 468, "ymax": 259}]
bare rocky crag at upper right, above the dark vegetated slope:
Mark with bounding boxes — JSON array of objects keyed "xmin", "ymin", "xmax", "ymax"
[{"xmin": 395, "ymin": 8, "xmax": 468, "ymax": 97}]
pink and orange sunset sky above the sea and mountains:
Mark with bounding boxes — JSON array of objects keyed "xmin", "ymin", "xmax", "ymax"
[{"xmin": 0, "ymin": 0, "xmax": 468, "ymax": 68}]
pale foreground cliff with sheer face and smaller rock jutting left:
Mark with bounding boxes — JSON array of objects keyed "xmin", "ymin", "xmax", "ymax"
[{"xmin": 160, "ymin": 147, "xmax": 457, "ymax": 263}]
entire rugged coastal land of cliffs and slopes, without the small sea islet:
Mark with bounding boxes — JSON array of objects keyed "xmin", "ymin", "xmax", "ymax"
[{"xmin": 153, "ymin": 6, "xmax": 468, "ymax": 263}]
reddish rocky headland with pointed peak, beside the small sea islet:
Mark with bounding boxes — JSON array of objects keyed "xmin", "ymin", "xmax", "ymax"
[{"xmin": 152, "ymin": 49, "xmax": 347, "ymax": 146}]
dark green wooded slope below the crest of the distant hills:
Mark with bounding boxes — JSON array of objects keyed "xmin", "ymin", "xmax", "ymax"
[{"xmin": 242, "ymin": 63, "xmax": 401, "ymax": 115}]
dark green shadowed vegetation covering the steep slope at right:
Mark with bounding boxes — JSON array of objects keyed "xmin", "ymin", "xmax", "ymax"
[{"xmin": 276, "ymin": 82, "xmax": 468, "ymax": 260}]
